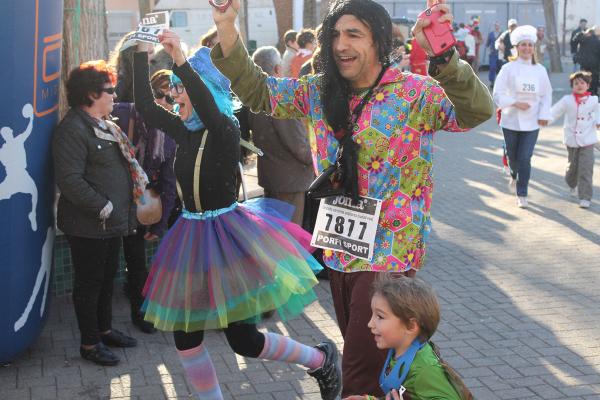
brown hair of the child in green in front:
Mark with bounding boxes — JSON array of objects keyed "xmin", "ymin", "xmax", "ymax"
[{"xmin": 373, "ymin": 273, "xmax": 440, "ymax": 342}]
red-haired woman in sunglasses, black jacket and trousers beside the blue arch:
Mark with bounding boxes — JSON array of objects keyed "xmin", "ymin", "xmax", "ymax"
[{"xmin": 52, "ymin": 61, "xmax": 148, "ymax": 365}]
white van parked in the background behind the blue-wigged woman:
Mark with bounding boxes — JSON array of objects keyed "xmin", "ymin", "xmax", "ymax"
[{"xmin": 154, "ymin": 0, "xmax": 279, "ymax": 47}]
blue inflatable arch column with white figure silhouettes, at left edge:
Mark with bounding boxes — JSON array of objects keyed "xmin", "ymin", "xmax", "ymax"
[{"xmin": 0, "ymin": 0, "xmax": 63, "ymax": 363}]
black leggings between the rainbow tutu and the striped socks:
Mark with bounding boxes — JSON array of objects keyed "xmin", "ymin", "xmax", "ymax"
[{"xmin": 173, "ymin": 322, "xmax": 265, "ymax": 358}]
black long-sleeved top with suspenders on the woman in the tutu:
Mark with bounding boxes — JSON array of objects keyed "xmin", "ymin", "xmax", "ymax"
[{"xmin": 133, "ymin": 52, "xmax": 240, "ymax": 212}]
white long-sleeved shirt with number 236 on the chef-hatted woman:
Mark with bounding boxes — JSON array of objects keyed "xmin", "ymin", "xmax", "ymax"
[{"xmin": 493, "ymin": 58, "xmax": 552, "ymax": 132}]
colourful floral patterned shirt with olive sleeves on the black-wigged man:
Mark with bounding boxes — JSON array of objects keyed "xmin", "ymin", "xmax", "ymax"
[{"xmin": 211, "ymin": 40, "xmax": 493, "ymax": 272}]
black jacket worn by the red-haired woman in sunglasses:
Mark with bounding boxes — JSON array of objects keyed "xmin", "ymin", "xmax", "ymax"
[{"xmin": 52, "ymin": 109, "xmax": 137, "ymax": 239}]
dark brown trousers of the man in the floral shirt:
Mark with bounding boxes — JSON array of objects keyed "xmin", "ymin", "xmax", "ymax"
[{"xmin": 329, "ymin": 269, "xmax": 416, "ymax": 398}]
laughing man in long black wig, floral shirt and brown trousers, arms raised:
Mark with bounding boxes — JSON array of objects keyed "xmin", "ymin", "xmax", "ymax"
[{"xmin": 211, "ymin": 0, "xmax": 493, "ymax": 397}]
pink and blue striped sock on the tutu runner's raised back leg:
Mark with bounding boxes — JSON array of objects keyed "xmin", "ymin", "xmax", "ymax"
[{"xmin": 258, "ymin": 332, "xmax": 325, "ymax": 369}]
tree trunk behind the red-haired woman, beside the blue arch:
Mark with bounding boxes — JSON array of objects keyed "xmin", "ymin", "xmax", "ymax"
[{"xmin": 59, "ymin": 0, "xmax": 108, "ymax": 118}]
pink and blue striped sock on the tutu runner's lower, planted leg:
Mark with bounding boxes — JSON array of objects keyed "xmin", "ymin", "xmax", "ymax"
[{"xmin": 177, "ymin": 344, "xmax": 223, "ymax": 400}]
